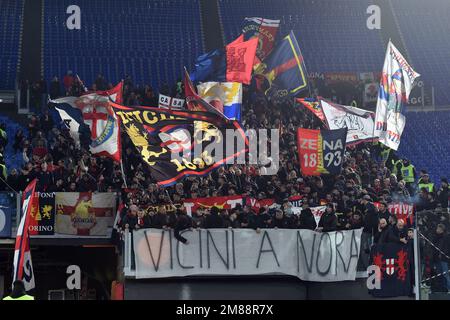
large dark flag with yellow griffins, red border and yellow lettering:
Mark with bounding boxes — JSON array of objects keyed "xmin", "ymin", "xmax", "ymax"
[{"xmin": 110, "ymin": 102, "xmax": 248, "ymax": 186}]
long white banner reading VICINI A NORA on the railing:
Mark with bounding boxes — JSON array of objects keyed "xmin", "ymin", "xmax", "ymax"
[{"xmin": 133, "ymin": 229, "xmax": 362, "ymax": 282}]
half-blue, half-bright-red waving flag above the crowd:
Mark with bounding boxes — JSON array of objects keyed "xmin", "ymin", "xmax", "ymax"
[{"xmin": 191, "ymin": 35, "xmax": 258, "ymax": 84}]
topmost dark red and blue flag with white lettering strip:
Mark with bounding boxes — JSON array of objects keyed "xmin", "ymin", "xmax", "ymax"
[{"xmin": 242, "ymin": 17, "xmax": 280, "ymax": 61}]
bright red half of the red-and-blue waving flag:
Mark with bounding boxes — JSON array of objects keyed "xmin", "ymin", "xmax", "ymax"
[{"xmin": 226, "ymin": 35, "xmax": 258, "ymax": 84}]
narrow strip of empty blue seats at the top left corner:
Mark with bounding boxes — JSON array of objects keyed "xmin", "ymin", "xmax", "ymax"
[{"xmin": 0, "ymin": 0, "xmax": 23, "ymax": 90}]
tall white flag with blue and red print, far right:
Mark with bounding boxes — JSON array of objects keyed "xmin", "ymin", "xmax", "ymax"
[{"xmin": 374, "ymin": 41, "xmax": 420, "ymax": 150}]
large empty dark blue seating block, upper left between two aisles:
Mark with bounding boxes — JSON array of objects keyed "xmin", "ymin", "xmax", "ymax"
[{"xmin": 43, "ymin": 0, "xmax": 204, "ymax": 88}]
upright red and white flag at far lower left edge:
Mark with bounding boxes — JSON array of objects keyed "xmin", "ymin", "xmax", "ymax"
[{"xmin": 13, "ymin": 179, "xmax": 38, "ymax": 291}]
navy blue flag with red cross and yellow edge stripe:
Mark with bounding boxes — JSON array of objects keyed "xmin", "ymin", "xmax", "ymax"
[{"xmin": 255, "ymin": 31, "xmax": 308, "ymax": 97}]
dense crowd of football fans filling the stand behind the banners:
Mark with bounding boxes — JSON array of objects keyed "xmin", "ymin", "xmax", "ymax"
[{"xmin": 2, "ymin": 73, "xmax": 450, "ymax": 288}]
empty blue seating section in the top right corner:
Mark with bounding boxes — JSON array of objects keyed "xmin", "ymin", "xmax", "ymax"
[{"xmin": 391, "ymin": 0, "xmax": 450, "ymax": 106}]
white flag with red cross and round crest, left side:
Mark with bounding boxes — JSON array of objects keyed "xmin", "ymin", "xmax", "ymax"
[{"xmin": 50, "ymin": 82, "xmax": 123, "ymax": 162}]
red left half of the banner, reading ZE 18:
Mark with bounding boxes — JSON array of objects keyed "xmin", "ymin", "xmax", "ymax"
[{"xmin": 297, "ymin": 128, "xmax": 320, "ymax": 176}]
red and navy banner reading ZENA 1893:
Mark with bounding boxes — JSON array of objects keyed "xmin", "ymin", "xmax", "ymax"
[{"xmin": 297, "ymin": 128, "xmax": 347, "ymax": 176}]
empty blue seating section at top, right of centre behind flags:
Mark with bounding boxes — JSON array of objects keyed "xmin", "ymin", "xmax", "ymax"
[{"xmin": 219, "ymin": 0, "xmax": 384, "ymax": 72}]
